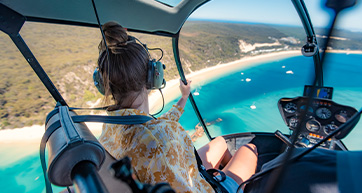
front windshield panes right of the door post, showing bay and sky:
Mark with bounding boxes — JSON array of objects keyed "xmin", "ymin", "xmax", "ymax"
[{"xmin": 179, "ymin": 1, "xmax": 362, "ymax": 149}]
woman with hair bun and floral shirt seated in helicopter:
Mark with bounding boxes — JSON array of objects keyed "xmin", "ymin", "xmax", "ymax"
[{"xmin": 98, "ymin": 22, "xmax": 257, "ymax": 192}]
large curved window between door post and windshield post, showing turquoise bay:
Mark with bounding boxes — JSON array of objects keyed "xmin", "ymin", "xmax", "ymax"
[{"xmin": 179, "ymin": 1, "xmax": 308, "ymax": 146}]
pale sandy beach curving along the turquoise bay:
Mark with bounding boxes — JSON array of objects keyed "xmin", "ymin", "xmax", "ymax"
[{"xmin": 0, "ymin": 50, "xmax": 362, "ymax": 164}]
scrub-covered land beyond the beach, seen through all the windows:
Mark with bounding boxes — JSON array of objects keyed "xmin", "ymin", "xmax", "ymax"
[{"xmin": 0, "ymin": 21, "xmax": 362, "ymax": 129}]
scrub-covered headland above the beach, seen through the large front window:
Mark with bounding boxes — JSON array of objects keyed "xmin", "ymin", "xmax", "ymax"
[{"xmin": 179, "ymin": 21, "xmax": 292, "ymax": 71}]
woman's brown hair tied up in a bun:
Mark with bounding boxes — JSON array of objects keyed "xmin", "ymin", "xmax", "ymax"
[{"xmin": 98, "ymin": 22, "xmax": 149, "ymax": 108}]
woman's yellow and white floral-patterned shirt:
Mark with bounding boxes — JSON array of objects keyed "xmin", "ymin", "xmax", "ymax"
[{"xmin": 99, "ymin": 105, "xmax": 214, "ymax": 192}]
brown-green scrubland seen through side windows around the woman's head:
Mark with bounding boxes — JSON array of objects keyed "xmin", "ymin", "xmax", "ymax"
[{"xmin": 0, "ymin": 22, "xmax": 178, "ymax": 129}]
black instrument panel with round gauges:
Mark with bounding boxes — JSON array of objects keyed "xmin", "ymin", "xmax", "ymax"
[{"xmin": 278, "ymin": 97, "xmax": 357, "ymax": 149}]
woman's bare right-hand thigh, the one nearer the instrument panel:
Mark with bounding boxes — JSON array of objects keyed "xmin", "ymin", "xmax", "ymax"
[{"xmin": 222, "ymin": 143, "xmax": 258, "ymax": 185}]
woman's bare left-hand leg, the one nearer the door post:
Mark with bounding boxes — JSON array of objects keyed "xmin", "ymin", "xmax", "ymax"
[{"xmin": 197, "ymin": 136, "xmax": 231, "ymax": 169}]
